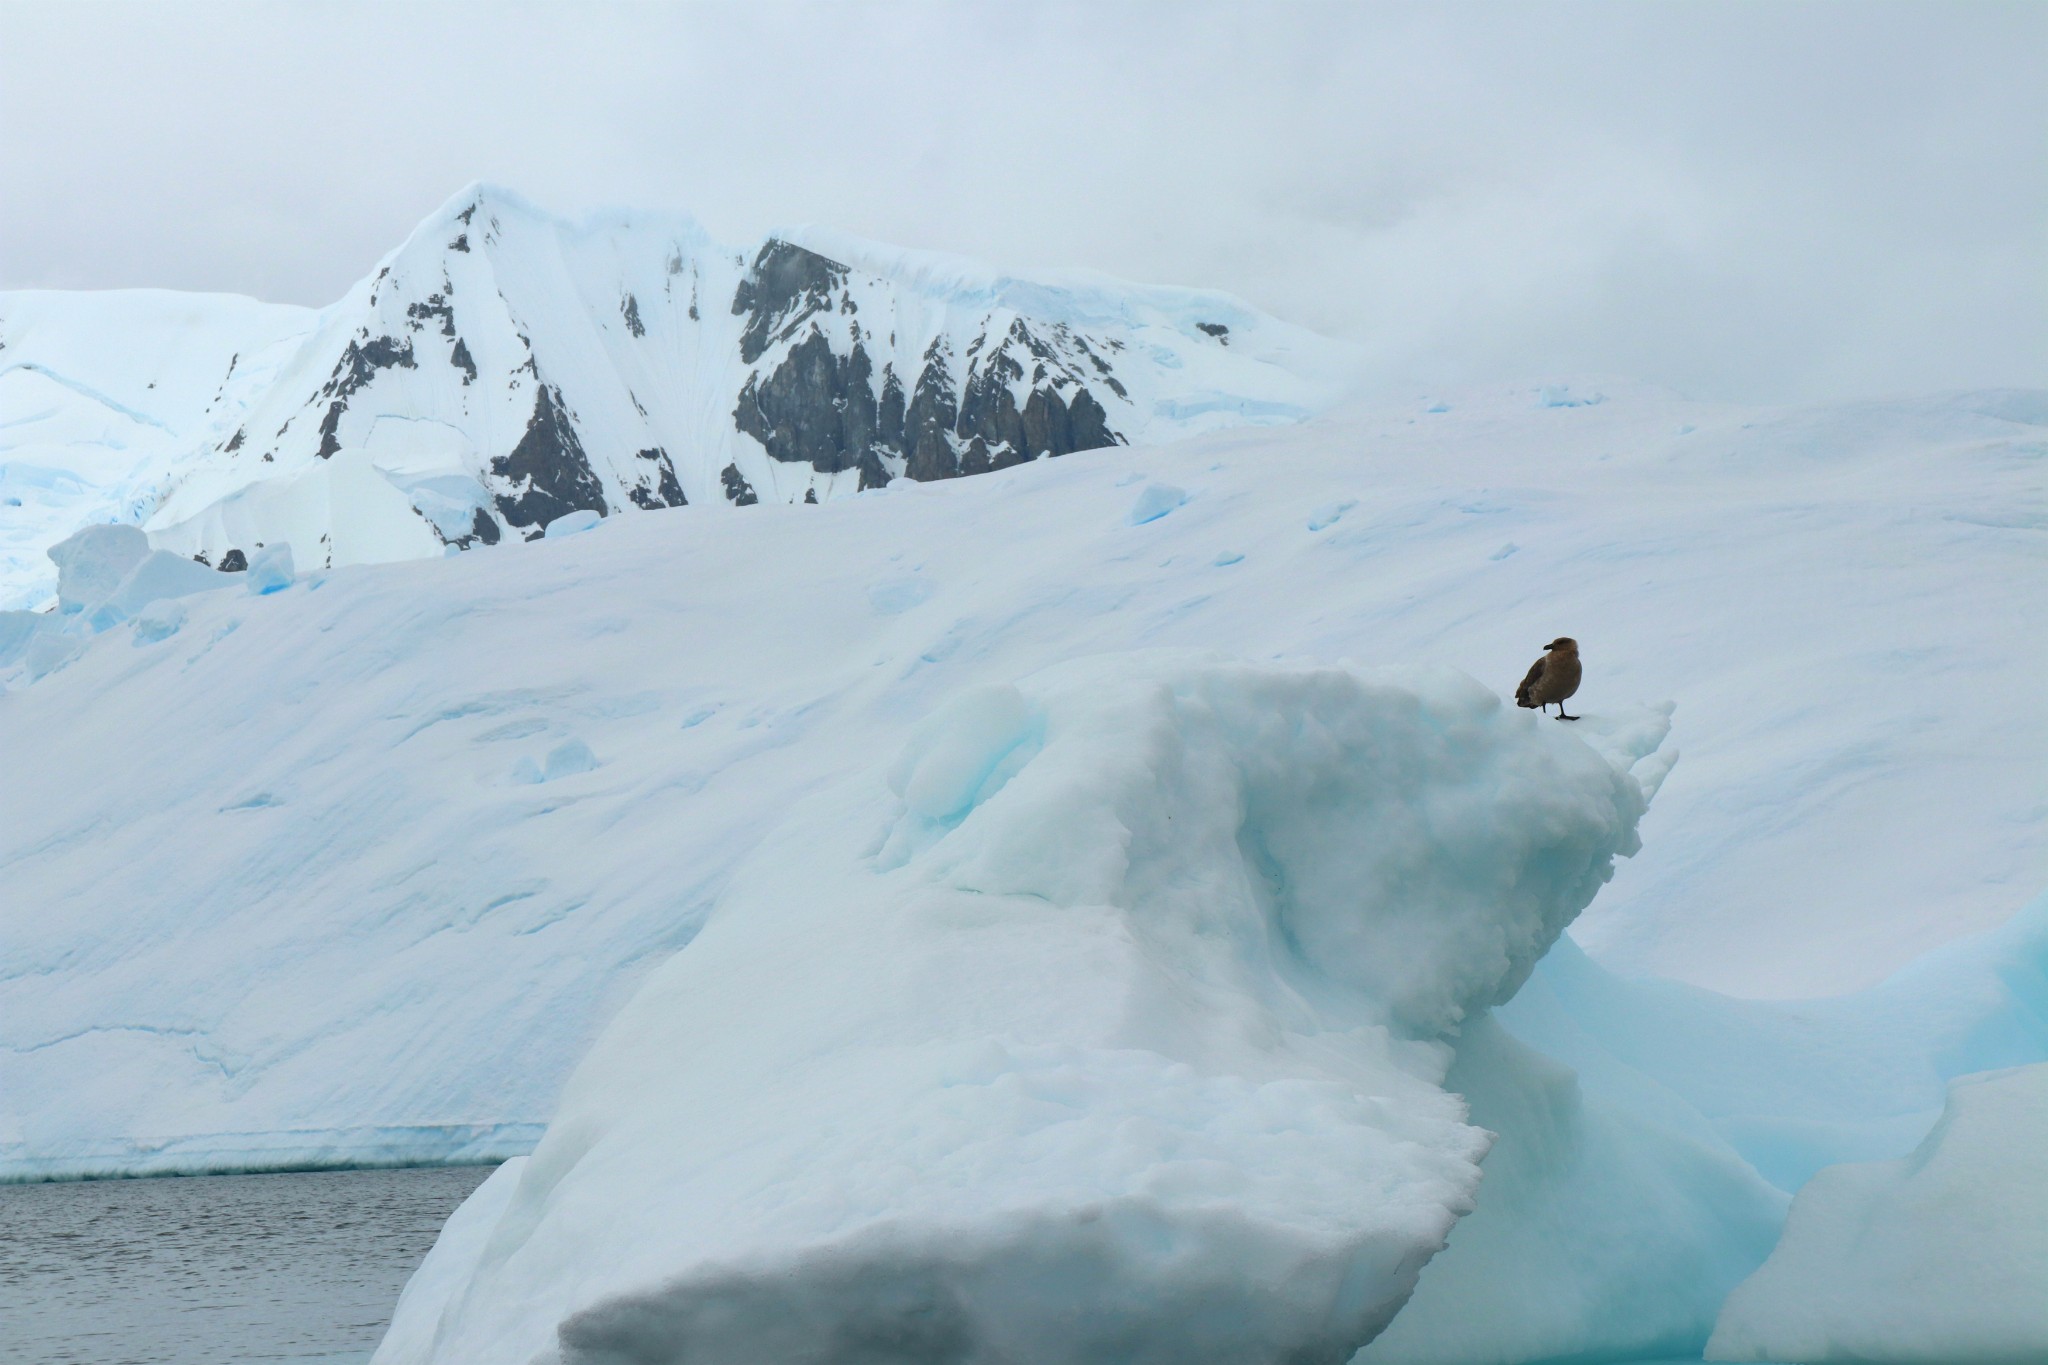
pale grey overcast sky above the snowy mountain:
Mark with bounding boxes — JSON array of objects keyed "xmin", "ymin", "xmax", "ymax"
[{"xmin": 0, "ymin": 0, "xmax": 2048, "ymax": 401}]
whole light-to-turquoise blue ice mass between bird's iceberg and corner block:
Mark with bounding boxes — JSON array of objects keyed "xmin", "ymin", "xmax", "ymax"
[{"xmin": 1358, "ymin": 892, "xmax": 2048, "ymax": 1365}]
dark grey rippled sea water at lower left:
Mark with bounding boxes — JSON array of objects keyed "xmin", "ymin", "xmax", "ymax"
[{"xmin": 0, "ymin": 1166, "xmax": 489, "ymax": 1365}]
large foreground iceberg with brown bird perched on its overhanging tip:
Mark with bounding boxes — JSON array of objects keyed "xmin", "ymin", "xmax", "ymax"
[{"xmin": 379, "ymin": 655, "xmax": 1661, "ymax": 1365}]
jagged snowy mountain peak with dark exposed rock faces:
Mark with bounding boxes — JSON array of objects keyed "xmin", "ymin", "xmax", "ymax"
[{"xmin": 119, "ymin": 188, "xmax": 1350, "ymax": 567}]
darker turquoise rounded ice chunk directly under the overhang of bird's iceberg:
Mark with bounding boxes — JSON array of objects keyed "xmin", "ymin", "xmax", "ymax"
[{"xmin": 1356, "ymin": 1015, "xmax": 1786, "ymax": 1365}]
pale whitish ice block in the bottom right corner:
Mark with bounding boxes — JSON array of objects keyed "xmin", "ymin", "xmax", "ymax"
[{"xmin": 1706, "ymin": 1064, "xmax": 2048, "ymax": 1365}]
